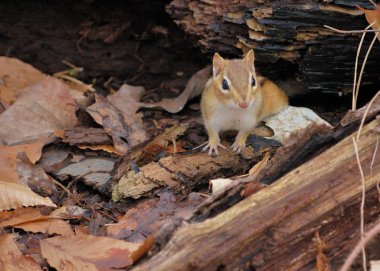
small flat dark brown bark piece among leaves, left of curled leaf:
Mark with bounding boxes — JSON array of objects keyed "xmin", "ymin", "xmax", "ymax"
[{"xmin": 64, "ymin": 127, "xmax": 112, "ymax": 145}]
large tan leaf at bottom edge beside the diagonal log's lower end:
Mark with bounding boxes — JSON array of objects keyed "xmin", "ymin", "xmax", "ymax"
[{"xmin": 40, "ymin": 235, "xmax": 151, "ymax": 271}]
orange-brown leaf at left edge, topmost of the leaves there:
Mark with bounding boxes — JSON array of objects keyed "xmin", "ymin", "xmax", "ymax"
[{"xmin": 0, "ymin": 56, "xmax": 46, "ymax": 104}]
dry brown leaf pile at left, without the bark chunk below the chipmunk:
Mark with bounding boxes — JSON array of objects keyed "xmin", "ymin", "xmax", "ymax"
[{"xmin": 0, "ymin": 57, "xmax": 211, "ymax": 270}]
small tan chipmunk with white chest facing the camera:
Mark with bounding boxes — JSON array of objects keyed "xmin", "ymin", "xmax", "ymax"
[{"xmin": 201, "ymin": 50, "xmax": 288, "ymax": 155}]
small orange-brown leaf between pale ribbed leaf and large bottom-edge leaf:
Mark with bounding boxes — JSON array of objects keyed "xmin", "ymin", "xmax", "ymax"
[{"xmin": 13, "ymin": 217, "xmax": 74, "ymax": 236}]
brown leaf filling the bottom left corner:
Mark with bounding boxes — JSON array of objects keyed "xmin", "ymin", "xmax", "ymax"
[{"xmin": 0, "ymin": 234, "xmax": 42, "ymax": 271}]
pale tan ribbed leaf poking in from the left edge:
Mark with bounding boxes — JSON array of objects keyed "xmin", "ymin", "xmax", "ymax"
[{"xmin": 0, "ymin": 181, "xmax": 57, "ymax": 211}]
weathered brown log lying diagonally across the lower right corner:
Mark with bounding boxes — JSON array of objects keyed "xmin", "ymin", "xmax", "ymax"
[{"xmin": 134, "ymin": 120, "xmax": 380, "ymax": 271}]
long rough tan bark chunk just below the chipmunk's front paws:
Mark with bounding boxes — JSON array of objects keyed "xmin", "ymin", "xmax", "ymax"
[{"xmin": 112, "ymin": 150, "xmax": 255, "ymax": 201}]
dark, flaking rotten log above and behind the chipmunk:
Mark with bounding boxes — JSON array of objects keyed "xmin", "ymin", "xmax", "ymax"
[{"xmin": 167, "ymin": 0, "xmax": 380, "ymax": 93}]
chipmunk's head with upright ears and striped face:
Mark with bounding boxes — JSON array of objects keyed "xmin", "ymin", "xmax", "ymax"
[{"xmin": 212, "ymin": 50, "xmax": 258, "ymax": 110}]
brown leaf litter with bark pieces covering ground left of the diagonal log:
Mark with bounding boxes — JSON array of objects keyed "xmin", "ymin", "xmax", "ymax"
[{"xmin": 0, "ymin": 54, "xmax": 332, "ymax": 270}]
